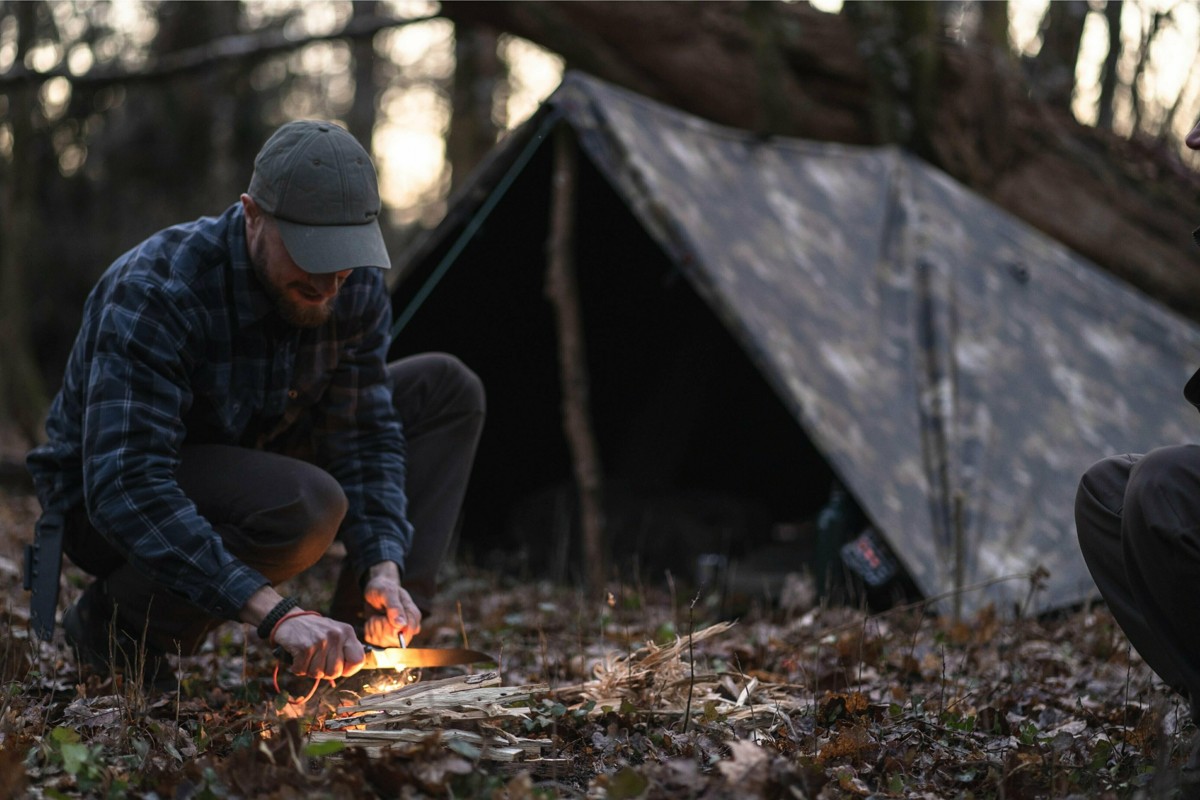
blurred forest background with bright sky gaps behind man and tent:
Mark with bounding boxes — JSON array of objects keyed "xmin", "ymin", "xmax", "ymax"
[{"xmin": 0, "ymin": 0, "xmax": 1200, "ymax": 462}]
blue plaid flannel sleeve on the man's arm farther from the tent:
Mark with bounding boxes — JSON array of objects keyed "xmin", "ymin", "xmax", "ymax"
[{"xmin": 83, "ymin": 279, "xmax": 268, "ymax": 619}]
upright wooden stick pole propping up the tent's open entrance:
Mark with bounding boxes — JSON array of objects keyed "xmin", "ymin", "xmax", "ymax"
[{"xmin": 545, "ymin": 125, "xmax": 607, "ymax": 593}]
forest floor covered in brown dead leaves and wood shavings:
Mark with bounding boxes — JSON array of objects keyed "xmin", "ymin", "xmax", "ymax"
[{"xmin": 0, "ymin": 479, "xmax": 1193, "ymax": 799}]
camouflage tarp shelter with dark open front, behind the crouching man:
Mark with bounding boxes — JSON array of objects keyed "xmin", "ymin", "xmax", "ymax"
[{"xmin": 394, "ymin": 73, "xmax": 1200, "ymax": 610}]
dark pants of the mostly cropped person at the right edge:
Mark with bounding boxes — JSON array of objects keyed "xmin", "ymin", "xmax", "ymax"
[{"xmin": 1075, "ymin": 445, "xmax": 1200, "ymax": 720}]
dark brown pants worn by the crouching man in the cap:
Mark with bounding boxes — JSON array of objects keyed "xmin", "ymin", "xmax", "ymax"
[{"xmin": 65, "ymin": 353, "xmax": 485, "ymax": 655}]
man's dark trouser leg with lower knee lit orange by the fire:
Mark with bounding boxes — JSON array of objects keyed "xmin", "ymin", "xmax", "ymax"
[{"xmin": 68, "ymin": 445, "xmax": 347, "ymax": 655}]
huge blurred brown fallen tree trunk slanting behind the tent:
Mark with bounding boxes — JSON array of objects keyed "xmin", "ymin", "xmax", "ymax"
[{"xmin": 443, "ymin": 0, "xmax": 1200, "ymax": 320}]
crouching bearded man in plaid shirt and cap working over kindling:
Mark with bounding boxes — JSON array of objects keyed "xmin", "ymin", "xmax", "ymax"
[{"xmin": 26, "ymin": 120, "xmax": 484, "ymax": 687}]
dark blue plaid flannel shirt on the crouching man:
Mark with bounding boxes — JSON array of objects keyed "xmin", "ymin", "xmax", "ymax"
[{"xmin": 28, "ymin": 203, "xmax": 412, "ymax": 619}]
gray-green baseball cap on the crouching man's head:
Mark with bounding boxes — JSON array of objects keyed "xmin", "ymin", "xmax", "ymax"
[{"xmin": 247, "ymin": 120, "xmax": 391, "ymax": 273}]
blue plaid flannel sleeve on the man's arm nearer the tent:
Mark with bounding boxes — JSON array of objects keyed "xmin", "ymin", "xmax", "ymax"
[{"xmin": 314, "ymin": 276, "xmax": 413, "ymax": 577}]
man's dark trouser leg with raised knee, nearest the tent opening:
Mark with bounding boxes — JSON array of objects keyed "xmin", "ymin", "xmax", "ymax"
[{"xmin": 330, "ymin": 353, "xmax": 486, "ymax": 620}]
